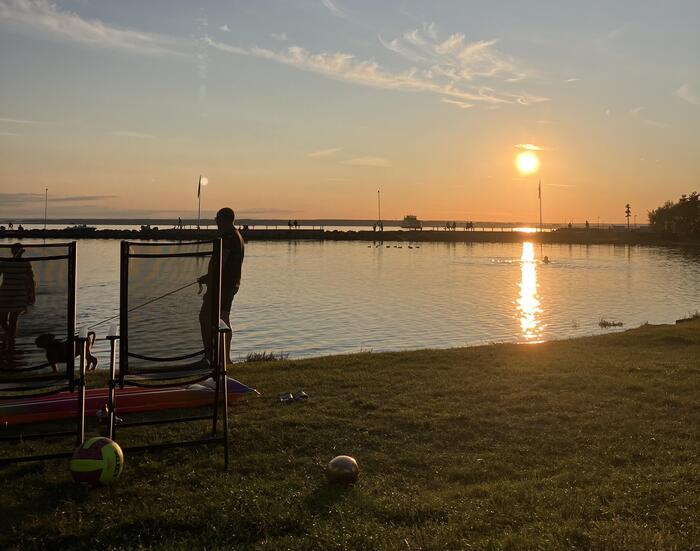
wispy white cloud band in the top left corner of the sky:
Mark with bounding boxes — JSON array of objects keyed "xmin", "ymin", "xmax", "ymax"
[{"xmin": 0, "ymin": 0, "xmax": 182, "ymax": 54}]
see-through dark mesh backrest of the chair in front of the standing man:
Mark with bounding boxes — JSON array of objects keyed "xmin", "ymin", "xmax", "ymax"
[{"xmin": 121, "ymin": 241, "xmax": 218, "ymax": 377}]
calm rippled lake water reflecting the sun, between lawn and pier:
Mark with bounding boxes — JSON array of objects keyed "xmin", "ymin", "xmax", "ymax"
[{"xmin": 5, "ymin": 240, "xmax": 700, "ymax": 366}]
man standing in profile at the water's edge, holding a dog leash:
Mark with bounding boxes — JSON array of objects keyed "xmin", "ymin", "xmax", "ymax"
[{"xmin": 197, "ymin": 207, "xmax": 245, "ymax": 364}]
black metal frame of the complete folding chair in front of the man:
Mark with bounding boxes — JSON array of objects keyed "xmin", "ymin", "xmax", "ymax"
[{"xmin": 107, "ymin": 239, "xmax": 230, "ymax": 469}]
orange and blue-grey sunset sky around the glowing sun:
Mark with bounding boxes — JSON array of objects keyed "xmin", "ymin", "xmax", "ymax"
[{"xmin": 0, "ymin": 0, "xmax": 700, "ymax": 223}]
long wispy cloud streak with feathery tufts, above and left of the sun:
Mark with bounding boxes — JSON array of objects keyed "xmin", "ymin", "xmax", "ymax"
[{"xmin": 207, "ymin": 30, "xmax": 548, "ymax": 106}]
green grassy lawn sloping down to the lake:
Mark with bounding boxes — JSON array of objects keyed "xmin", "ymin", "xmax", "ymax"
[{"xmin": 0, "ymin": 320, "xmax": 700, "ymax": 550}]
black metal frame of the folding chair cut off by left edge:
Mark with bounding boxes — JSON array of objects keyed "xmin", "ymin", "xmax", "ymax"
[{"xmin": 0, "ymin": 241, "xmax": 88, "ymax": 465}]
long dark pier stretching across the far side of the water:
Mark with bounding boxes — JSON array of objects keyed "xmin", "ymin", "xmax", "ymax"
[{"xmin": 0, "ymin": 228, "xmax": 700, "ymax": 247}]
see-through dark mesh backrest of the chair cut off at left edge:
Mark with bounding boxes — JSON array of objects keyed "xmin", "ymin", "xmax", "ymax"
[{"xmin": 0, "ymin": 244, "xmax": 75, "ymax": 393}]
